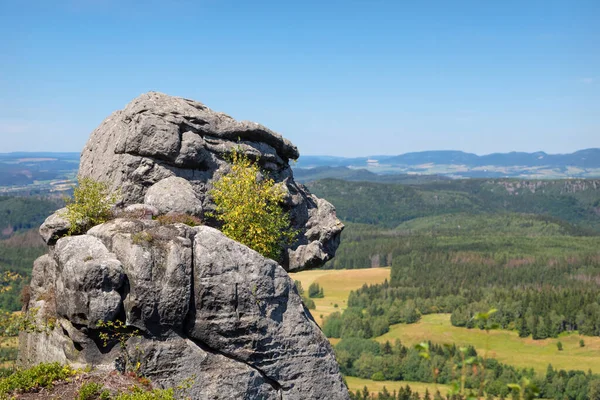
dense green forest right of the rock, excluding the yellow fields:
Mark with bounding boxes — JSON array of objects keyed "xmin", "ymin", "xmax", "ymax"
[{"xmin": 308, "ymin": 180, "xmax": 600, "ymax": 399}]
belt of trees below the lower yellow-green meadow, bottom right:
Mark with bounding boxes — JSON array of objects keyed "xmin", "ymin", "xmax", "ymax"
[{"xmin": 335, "ymin": 338, "xmax": 600, "ymax": 400}]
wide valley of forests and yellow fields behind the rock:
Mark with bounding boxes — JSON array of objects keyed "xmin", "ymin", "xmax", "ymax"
[{"xmin": 0, "ymin": 170, "xmax": 600, "ymax": 398}]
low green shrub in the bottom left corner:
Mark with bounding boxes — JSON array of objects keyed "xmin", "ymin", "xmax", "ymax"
[{"xmin": 0, "ymin": 363, "xmax": 76, "ymax": 399}]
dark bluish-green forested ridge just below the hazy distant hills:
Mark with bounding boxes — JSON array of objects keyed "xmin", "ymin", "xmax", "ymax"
[{"xmin": 306, "ymin": 179, "xmax": 600, "ymax": 232}]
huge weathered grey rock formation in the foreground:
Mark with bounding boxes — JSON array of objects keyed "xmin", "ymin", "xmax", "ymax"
[{"xmin": 19, "ymin": 93, "xmax": 349, "ymax": 400}]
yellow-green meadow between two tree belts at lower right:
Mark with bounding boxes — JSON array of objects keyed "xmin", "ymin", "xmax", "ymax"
[{"xmin": 376, "ymin": 314, "xmax": 600, "ymax": 374}]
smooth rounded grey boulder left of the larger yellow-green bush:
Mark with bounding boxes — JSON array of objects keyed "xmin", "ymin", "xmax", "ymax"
[{"xmin": 144, "ymin": 176, "xmax": 202, "ymax": 217}]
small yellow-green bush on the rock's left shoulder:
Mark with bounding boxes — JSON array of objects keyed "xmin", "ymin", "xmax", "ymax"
[{"xmin": 63, "ymin": 178, "xmax": 117, "ymax": 235}]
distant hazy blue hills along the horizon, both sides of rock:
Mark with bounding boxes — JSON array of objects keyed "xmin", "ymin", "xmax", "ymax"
[{"xmin": 0, "ymin": 148, "xmax": 600, "ymax": 193}]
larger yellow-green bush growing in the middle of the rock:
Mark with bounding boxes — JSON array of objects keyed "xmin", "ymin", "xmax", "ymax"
[{"xmin": 211, "ymin": 151, "xmax": 296, "ymax": 259}]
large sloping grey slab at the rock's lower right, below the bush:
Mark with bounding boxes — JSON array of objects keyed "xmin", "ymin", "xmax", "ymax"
[{"xmin": 187, "ymin": 226, "xmax": 348, "ymax": 399}]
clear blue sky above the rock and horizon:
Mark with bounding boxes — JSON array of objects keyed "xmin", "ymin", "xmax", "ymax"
[{"xmin": 0, "ymin": 0, "xmax": 600, "ymax": 156}]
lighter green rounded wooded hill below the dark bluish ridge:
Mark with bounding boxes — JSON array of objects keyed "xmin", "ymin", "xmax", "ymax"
[{"xmin": 324, "ymin": 213, "xmax": 600, "ymax": 269}]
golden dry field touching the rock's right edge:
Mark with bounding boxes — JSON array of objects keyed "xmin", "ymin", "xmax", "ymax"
[{"xmin": 290, "ymin": 267, "xmax": 390, "ymax": 325}]
